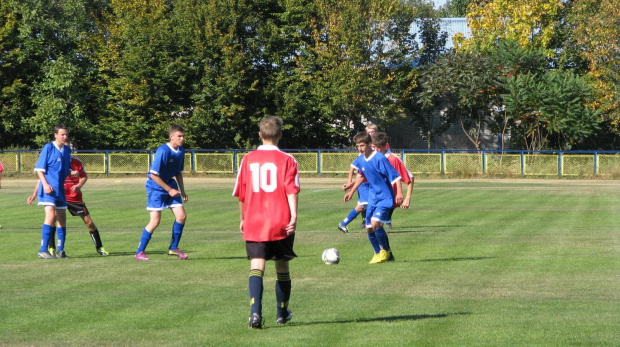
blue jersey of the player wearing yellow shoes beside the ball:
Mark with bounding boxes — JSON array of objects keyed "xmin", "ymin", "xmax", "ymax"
[{"xmin": 351, "ymin": 151, "xmax": 401, "ymax": 208}]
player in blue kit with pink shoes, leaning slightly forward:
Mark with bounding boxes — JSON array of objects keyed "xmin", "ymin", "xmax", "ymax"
[{"xmin": 134, "ymin": 124, "xmax": 188, "ymax": 261}]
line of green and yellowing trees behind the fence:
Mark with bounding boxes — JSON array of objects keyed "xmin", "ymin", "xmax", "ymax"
[{"xmin": 0, "ymin": 0, "xmax": 620, "ymax": 150}]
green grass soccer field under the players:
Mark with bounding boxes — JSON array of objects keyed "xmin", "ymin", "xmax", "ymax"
[{"xmin": 0, "ymin": 178, "xmax": 620, "ymax": 346}]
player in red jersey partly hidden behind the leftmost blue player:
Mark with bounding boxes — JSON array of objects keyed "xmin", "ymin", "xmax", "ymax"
[{"xmin": 27, "ymin": 138, "xmax": 109, "ymax": 256}]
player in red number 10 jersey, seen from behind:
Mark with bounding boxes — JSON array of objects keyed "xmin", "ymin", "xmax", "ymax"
[{"xmin": 233, "ymin": 116, "xmax": 300, "ymax": 329}]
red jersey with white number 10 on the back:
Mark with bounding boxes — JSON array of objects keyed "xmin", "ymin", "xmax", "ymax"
[{"xmin": 233, "ymin": 145, "xmax": 299, "ymax": 242}]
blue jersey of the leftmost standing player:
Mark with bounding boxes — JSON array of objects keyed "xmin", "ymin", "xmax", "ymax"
[{"xmin": 34, "ymin": 142, "xmax": 71, "ymax": 201}]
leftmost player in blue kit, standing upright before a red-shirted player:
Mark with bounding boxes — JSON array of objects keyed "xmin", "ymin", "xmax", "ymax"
[{"xmin": 34, "ymin": 124, "xmax": 71, "ymax": 259}]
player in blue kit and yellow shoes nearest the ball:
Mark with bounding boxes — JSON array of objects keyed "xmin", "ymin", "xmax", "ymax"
[{"xmin": 344, "ymin": 132, "xmax": 403, "ymax": 264}]
